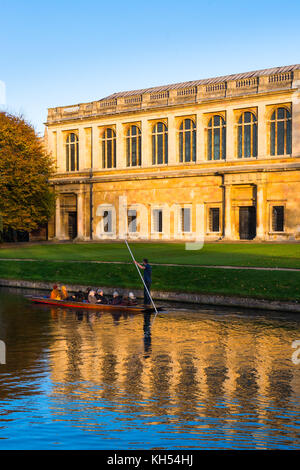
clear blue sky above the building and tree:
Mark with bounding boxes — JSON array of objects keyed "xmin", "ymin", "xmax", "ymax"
[{"xmin": 0, "ymin": 0, "xmax": 300, "ymax": 133}]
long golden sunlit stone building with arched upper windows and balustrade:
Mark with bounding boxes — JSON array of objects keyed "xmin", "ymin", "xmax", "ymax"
[{"xmin": 46, "ymin": 64, "xmax": 300, "ymax": 241}]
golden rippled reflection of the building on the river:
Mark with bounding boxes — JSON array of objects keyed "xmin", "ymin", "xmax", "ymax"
[{"xmin": 50, "ymin": 309, "xmax": 300, "ymax": 445}]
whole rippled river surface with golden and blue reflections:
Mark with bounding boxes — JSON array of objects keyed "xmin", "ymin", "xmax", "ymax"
[{"xmin": 0, "ymin": 289, "xmax": 300, "ymax": 450}]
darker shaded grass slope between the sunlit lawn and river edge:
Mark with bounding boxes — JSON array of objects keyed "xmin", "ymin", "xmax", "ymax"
[{"xmin": 0, "ymin": 260, "xmax": 300, "ymax": 300}]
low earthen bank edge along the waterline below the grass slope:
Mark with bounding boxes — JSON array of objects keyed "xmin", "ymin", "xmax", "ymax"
[{"xmin": 0, "ymin": 279, "xmax": 300, "ymax": 313}]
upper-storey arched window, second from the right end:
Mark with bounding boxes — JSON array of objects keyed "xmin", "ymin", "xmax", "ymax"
[{"xmin": 238, "ymin": 111, "xmax": 257, "ymax": 158}]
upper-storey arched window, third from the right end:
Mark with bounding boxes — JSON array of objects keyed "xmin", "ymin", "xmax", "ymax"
[{"xmin": 207, "ymin": 114, "xmax": 226, "ymax": 160}]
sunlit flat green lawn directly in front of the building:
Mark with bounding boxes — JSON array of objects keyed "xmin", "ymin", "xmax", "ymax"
[{"xmin": 0, "ymin": 243, "xmax": 300, "ymax": 268}]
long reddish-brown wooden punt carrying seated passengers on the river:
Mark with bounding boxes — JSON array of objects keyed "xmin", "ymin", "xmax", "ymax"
[{"xmin": 26, "ymin": 296, "xmax": 163, "ymax": 313}]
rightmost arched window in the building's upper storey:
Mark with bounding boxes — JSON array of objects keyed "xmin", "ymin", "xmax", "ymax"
[{"xmin": 270, "ymin": 108, "xmax": 292, "ymax": 155}]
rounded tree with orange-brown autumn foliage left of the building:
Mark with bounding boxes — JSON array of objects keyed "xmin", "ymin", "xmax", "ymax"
[{"xmin": 0, "ymin": 112, "xmax": 54, "ymax": 231}]
